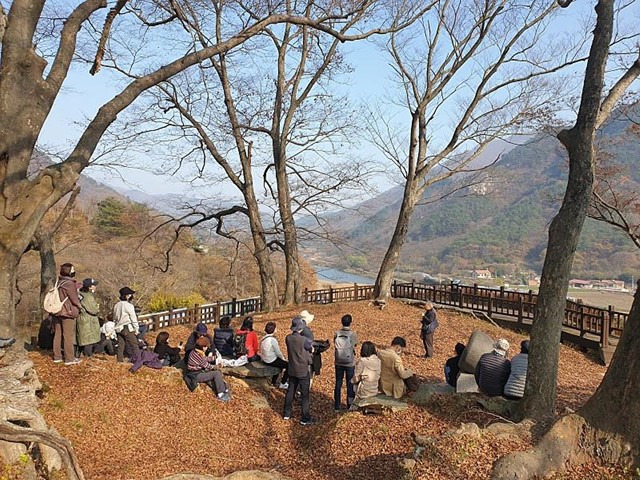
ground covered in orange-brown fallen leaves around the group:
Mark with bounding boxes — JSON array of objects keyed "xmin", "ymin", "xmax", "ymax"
[{"xmin": 32, "ymin": 301, "xmax": 632, "ymax": 480}]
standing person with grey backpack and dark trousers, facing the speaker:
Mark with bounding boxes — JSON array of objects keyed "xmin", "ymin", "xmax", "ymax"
[{"xmin": 333, "ymin": 314, "xmax": 358, "ymax": 412}]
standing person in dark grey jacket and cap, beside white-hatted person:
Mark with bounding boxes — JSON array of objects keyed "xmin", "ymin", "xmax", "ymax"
[{"xmin": 283, "ymin": 317, "xmax": 315, "ymax": 426}]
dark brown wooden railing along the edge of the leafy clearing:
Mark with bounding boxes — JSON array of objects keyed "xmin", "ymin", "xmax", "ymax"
[{"xmin": 140, "ymin": 281, "xmax": 628, "ymax": 345}]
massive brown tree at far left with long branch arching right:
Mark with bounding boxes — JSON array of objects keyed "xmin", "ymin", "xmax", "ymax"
[{"xmin": 0, "ymin": 0, "xmax": 408, "ymax": 337}]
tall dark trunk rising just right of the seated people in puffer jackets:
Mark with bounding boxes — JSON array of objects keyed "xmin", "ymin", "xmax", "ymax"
[{"xmin": 522, "ymin": 0, "xmax": 614, "ymax": 420}]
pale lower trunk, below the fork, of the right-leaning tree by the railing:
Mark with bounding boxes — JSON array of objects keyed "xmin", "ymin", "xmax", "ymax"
[{"xmin": 373, "ymin": 180, "xmax": 420, "ymax": 301}]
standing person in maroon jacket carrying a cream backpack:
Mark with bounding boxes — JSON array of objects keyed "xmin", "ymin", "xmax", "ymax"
[{"xmin": 53, "ymin": 263, "xmax": 82, "ymax": 365}]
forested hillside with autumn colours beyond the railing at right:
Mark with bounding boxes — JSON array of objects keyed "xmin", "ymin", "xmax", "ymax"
[{"xmin": 311, "ymin": 114, "xmax": 640, "ymax": 277}]
